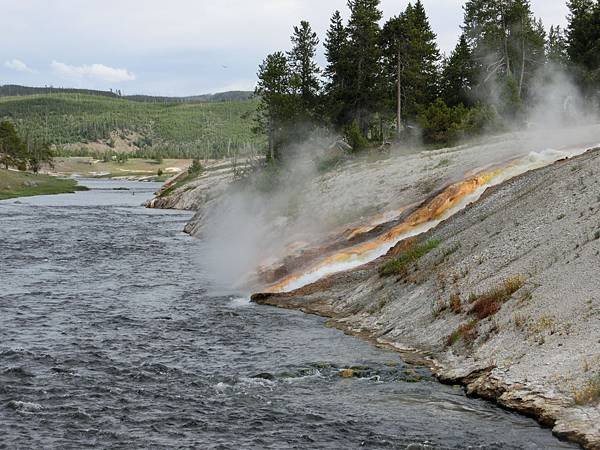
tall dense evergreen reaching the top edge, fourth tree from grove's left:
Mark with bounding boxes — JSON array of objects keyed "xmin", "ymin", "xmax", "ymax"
[{"xmin": 344, "ymin": 0, "xmax": 382, "ymax": 134}]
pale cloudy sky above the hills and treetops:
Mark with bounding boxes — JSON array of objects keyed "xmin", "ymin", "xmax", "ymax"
[{"xmin": 0, "ymin": 0, "xmax": 567, "ymax": 96}]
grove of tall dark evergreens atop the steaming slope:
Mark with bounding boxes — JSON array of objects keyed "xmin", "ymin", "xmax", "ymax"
[{"xmin": 256, "ymin": 0, "xmax": 600, "ymax": 159}]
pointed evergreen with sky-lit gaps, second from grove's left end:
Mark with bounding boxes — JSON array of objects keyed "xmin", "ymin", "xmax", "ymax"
[{"xmin": 288, "ymin": 20, "xmax": 321, "ymax": 114}]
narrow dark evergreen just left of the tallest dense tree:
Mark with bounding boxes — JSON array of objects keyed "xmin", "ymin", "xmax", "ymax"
[{"xmin": 324, "ymin": 11, "xmax": 350, "ymax": 127}]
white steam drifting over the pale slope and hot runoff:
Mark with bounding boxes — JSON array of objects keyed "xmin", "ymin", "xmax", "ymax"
[{"xmin": 201, "ymin": 68, "xmax": 600, "ymax": 293}]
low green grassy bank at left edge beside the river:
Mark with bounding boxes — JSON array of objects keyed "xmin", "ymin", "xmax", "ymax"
[{"xmin": 0, "ymin": 169, "xmax": 87, "ymax": 200}]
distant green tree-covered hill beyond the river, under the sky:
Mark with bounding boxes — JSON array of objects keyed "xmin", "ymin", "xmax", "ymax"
[{"xmin": 0, "ymin": 92, "xmax": 263, "ymax": 158}]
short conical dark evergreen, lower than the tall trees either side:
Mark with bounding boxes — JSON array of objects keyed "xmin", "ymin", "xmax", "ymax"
[{"xmin": 441, "ymin": 35, "xmax": 477, "ymax": 106}]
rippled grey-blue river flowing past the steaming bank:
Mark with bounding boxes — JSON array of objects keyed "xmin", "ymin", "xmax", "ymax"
[{"xmin": 0, "ymin": 180, "xmax": 573, "ymax": 449}]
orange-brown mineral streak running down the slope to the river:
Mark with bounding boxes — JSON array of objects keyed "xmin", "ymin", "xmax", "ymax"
[{"xmin": 265, "ymin": 169, "xmax": 502, "ymax": 293}]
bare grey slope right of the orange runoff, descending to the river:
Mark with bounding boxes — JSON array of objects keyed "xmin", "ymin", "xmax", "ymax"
[{"xmin": 253, "ymin": 150, "xmax": 600, "ymax": 449}]
